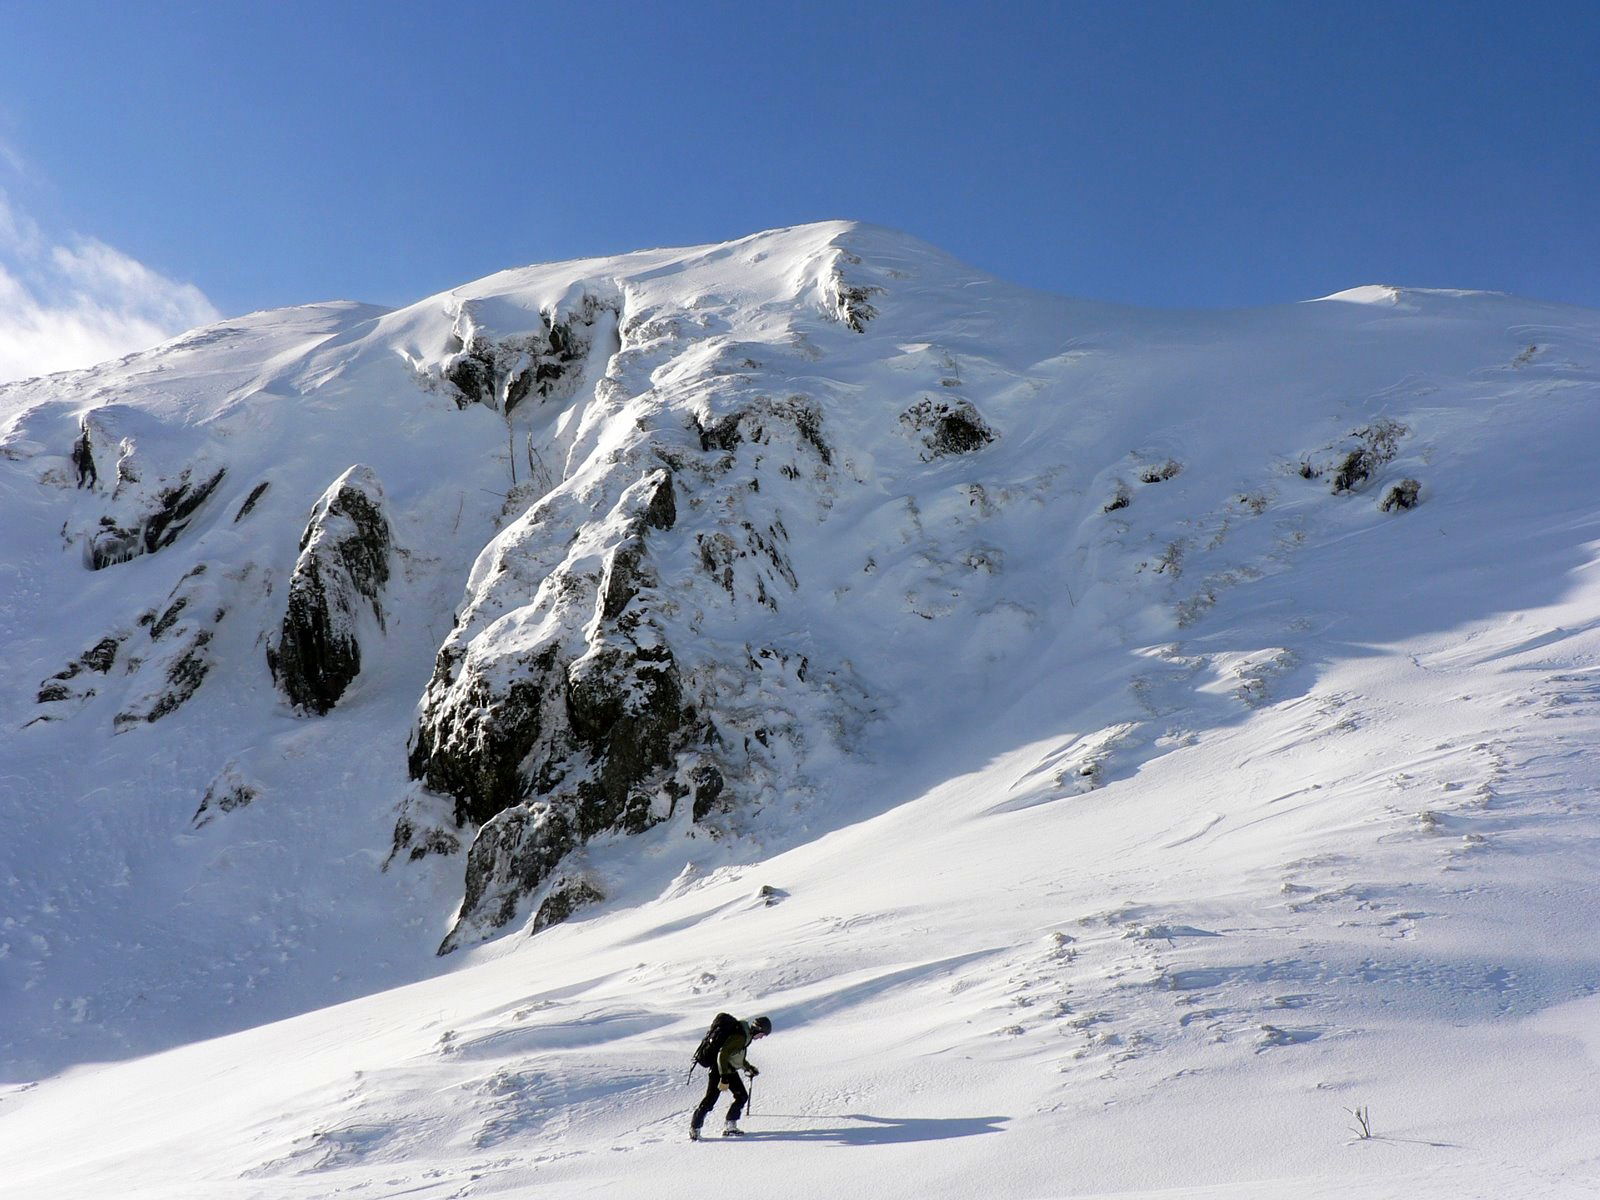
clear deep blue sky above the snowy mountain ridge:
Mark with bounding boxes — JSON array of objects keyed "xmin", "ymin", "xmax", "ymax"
[{"xmin": 0, "ymin": 0, "xmax": 1600, "ymax": 376}]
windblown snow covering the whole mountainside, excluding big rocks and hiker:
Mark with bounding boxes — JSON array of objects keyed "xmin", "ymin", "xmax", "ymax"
[{"xmin": 0, "ymin": 224, "xmax": 1600, "ymax": 1200}]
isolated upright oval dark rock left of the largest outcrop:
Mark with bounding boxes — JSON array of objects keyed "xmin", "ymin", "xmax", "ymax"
[{"xmin": 267, "ymin": 466, "xmax": 392, "ymax": 715}]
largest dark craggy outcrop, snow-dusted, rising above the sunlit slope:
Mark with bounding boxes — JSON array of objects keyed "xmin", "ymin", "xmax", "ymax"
[{"xmin": 406, "ymin": 469, "xmax": 710, "ymax": 952}]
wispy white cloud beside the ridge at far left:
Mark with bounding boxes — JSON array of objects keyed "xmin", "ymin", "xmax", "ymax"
[{"xmin": 0, "ymin": 190, "xmax": 221, "ymax": 382}]
